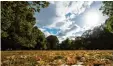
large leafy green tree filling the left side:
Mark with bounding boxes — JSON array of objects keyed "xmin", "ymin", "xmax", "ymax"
[{"xmin": 1, "ymin": 1, "xmax": 49, "ymax": 49}]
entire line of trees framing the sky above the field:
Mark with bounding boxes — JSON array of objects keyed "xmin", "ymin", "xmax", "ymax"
[{"xmin": 1, "ymin": 1, "xmax": 113, "ymax": 50}]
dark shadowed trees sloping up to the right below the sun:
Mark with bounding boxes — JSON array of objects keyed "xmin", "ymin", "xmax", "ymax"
[{"xmin": 82, "ymin": 24, "xmax": 113, "ymax": 49}]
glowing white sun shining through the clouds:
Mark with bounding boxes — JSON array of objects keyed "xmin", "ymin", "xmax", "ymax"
[{"xmin": 85, "ymin": 11, "xmax": 100, "ymax": 27}]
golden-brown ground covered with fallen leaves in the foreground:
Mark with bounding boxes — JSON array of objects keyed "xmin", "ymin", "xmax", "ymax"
[{"xmin": 1, "ymin": 50, "xmax": 113, "ymax": 66}]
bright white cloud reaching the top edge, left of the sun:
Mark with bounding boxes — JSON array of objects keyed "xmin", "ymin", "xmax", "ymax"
[{"xmin": 49, "ymin": 1, "xmax": 92, "ymax": 27}]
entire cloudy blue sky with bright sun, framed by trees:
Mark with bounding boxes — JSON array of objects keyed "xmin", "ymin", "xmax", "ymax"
[{"xmin": 35, "ymin": 1, "xmax": 108, "ymax": 41}]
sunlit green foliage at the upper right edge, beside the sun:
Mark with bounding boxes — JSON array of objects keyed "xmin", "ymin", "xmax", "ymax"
[{"xmin": 100, "ymin": 1, "xmax": 113, "ymax": 33}]
